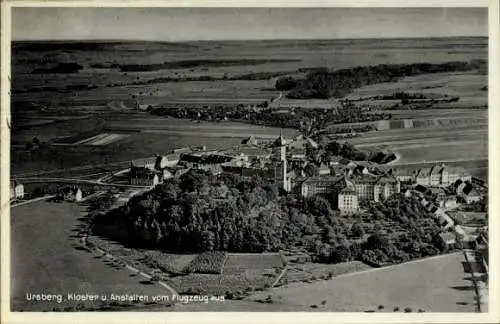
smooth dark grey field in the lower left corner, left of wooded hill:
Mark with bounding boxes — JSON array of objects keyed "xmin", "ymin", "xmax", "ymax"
[{"xmin": 11, "ymin": 202, "xmax": 167, "ymax": 311}]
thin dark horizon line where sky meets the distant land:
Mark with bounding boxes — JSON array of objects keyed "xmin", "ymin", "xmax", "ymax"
[{"xmin": 11, "ymin": 35, "xmax": 489, "ymax": 43}]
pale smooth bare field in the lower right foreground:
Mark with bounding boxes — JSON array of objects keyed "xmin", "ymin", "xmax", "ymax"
[{"xmin": 250, "ymin": 253, "xmax": 475, "ymax": 312}]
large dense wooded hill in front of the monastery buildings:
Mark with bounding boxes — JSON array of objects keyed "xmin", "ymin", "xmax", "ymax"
[{"xmin": 91, "ymin": 171, "xmax": 444, "ymax": 264}]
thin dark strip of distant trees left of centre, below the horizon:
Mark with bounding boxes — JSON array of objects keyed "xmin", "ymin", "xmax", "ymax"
[{"xmin": 90, "ymin": 59, "xmax": 300, "ymax": 72}]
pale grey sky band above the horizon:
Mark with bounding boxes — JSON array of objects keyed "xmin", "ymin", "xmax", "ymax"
[{"xmin": 12, "ymin": 7, "xmax": 488, "ymax": 41}]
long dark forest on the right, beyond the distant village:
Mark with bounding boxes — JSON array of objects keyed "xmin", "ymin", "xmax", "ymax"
[{"xmin": 276, "ymin": 60, "xmax": 487, "ymax": 99}]
